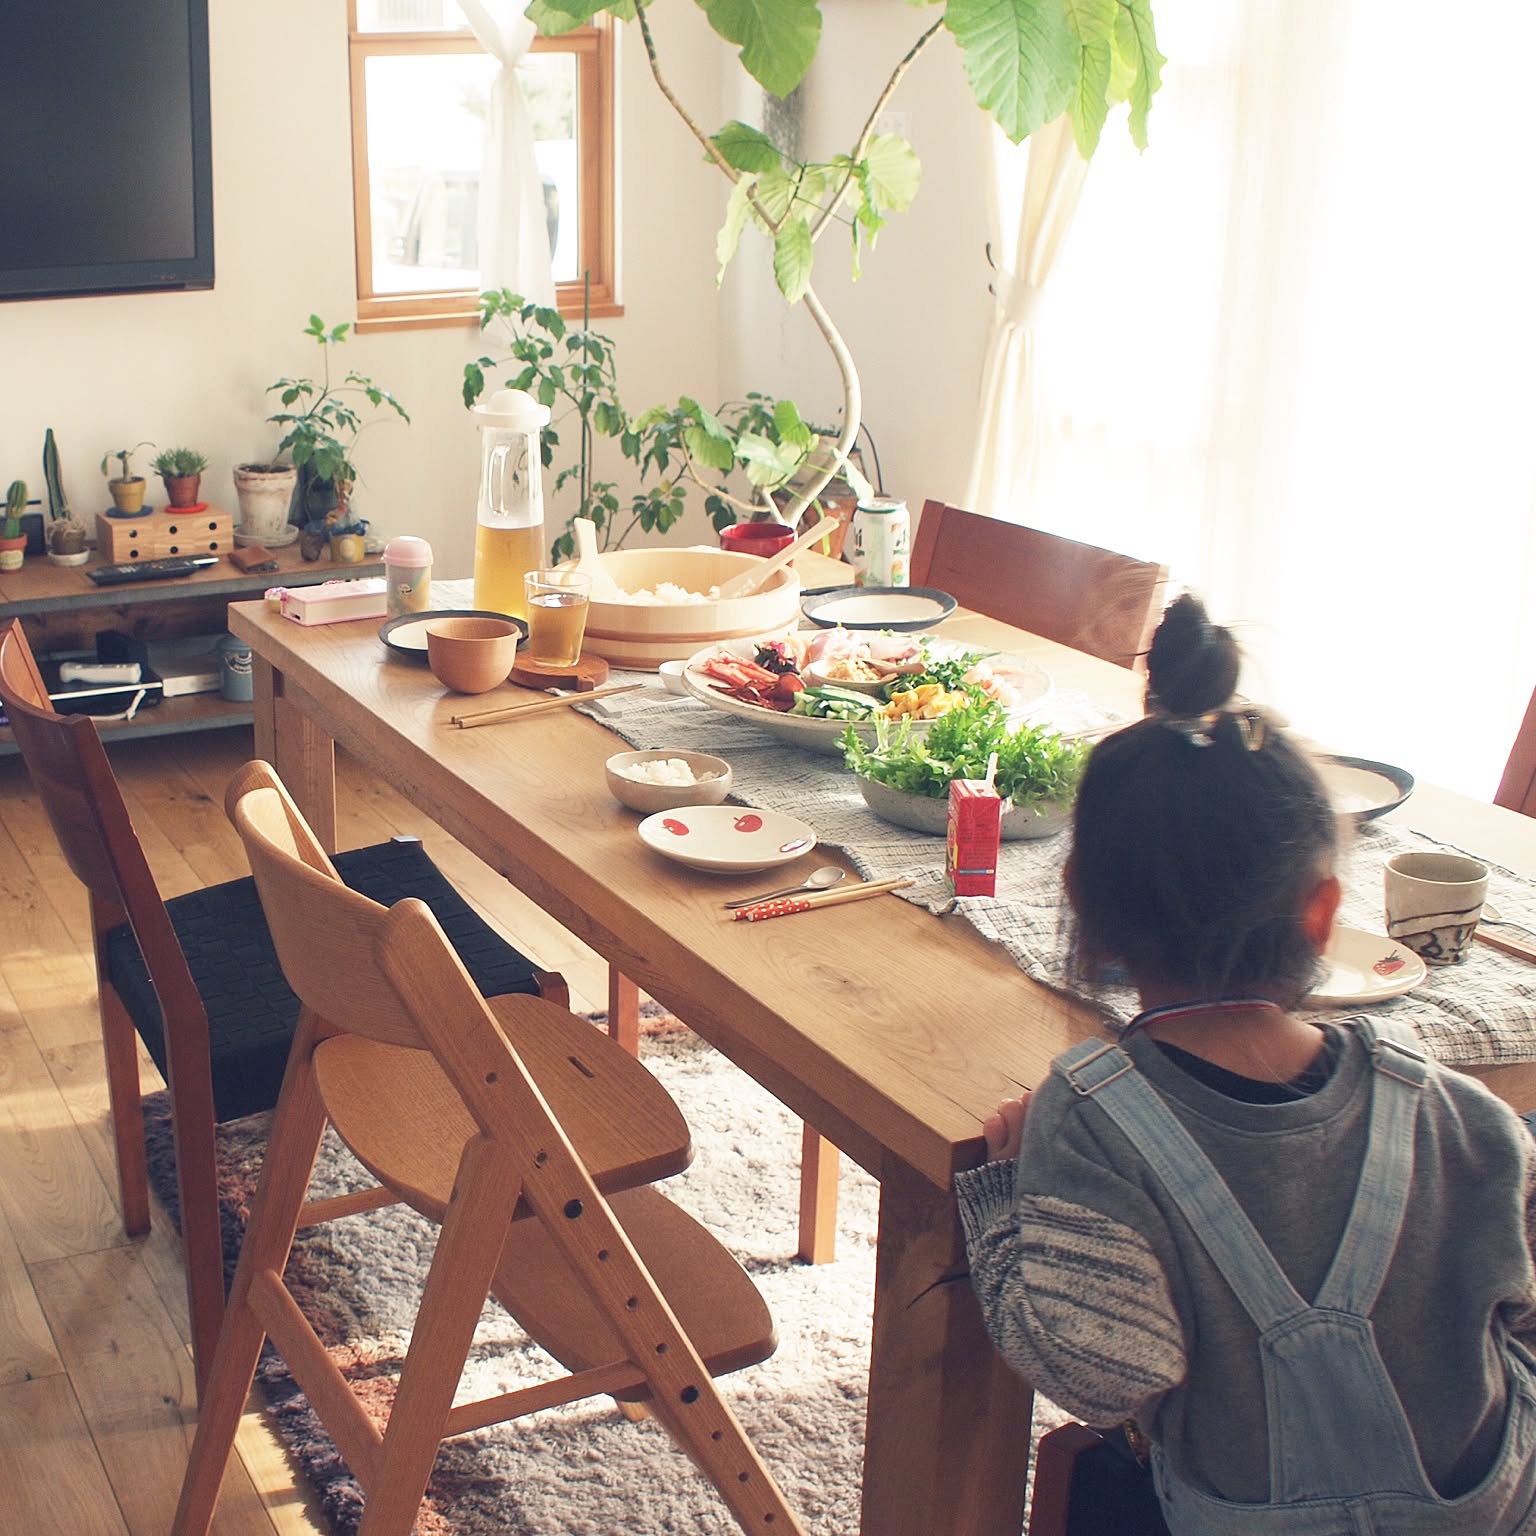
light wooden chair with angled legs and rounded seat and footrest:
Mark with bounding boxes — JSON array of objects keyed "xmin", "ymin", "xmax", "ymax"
[{"xmin": 172, "ymin": 763, "xmax": 802, "ymax": 1536}]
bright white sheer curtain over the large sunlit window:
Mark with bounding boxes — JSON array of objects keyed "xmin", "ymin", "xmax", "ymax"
[{"xmin": 978, "ymin": 0, "xmax": 1536, "ymax": 797}]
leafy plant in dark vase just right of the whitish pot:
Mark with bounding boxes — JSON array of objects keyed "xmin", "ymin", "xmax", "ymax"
[{"xmin": 267, "ymin": 315, "xmax": 410, "ymax": 524}]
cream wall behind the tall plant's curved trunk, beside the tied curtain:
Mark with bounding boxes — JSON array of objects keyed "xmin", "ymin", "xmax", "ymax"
[{"xmin": 722, "ymin": 0, "xmax": 992, "ymax": 513}]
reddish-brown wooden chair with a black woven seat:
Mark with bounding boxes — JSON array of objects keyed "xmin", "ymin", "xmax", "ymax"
[{"xmin": 0, "ymin": 621, "xmax": 567, "ymax": 1387}]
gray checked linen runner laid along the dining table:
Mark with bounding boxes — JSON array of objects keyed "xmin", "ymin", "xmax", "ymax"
[{"xmin": 579, "ymin": 671, "xmax": 1536, "ymax": 1066}]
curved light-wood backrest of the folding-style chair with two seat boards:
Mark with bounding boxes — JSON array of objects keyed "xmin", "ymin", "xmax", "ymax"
[{"xmin": 224, "ymin": 762, "xmax": 433, "ymax": 1048}]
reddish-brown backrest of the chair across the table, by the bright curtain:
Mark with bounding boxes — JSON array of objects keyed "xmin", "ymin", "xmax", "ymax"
[{"xmin": 911, "ymin": 501, "xmax": 1167, "ymax": 671}]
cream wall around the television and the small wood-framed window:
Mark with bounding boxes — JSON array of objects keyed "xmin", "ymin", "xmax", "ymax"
[{"xmin": 0, "ymin": 0, "xmax": 719, "ymax": 574}]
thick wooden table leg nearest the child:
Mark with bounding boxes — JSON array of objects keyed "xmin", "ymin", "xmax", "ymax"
[{"xmin": 860, "ymin": 1161, "xmax": 1034, "ymax": 1536}]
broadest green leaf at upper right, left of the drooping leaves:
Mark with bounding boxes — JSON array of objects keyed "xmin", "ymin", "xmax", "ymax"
[{"xmin": 945, "ymin": 0, "xmax": 1080, "ymax": 144}]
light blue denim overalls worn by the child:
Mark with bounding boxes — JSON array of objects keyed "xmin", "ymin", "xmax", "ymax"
[{"xmin": 1057, "ymin": 1020, "xmax": 1536, "ymax": 1536}]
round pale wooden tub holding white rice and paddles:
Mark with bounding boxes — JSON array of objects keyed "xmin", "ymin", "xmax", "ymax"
[{"xmin": 582, "ymin": 548, "xmax": 800, "ymax": 671}]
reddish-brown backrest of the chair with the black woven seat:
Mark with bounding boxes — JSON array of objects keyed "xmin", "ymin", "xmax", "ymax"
[{"xmin": 0, "ymin": 619, "xmax": 203, "ymax": 1017}]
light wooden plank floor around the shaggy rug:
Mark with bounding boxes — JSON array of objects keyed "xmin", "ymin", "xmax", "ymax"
[{"xmin": 0, "ymin": 730, "xmax": 607, "ymax": 1536}]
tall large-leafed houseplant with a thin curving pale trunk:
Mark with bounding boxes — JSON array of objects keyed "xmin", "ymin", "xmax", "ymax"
[{"xmin": 528, "ymin": 0, "xmax": 1163, "ymax": 522}]
